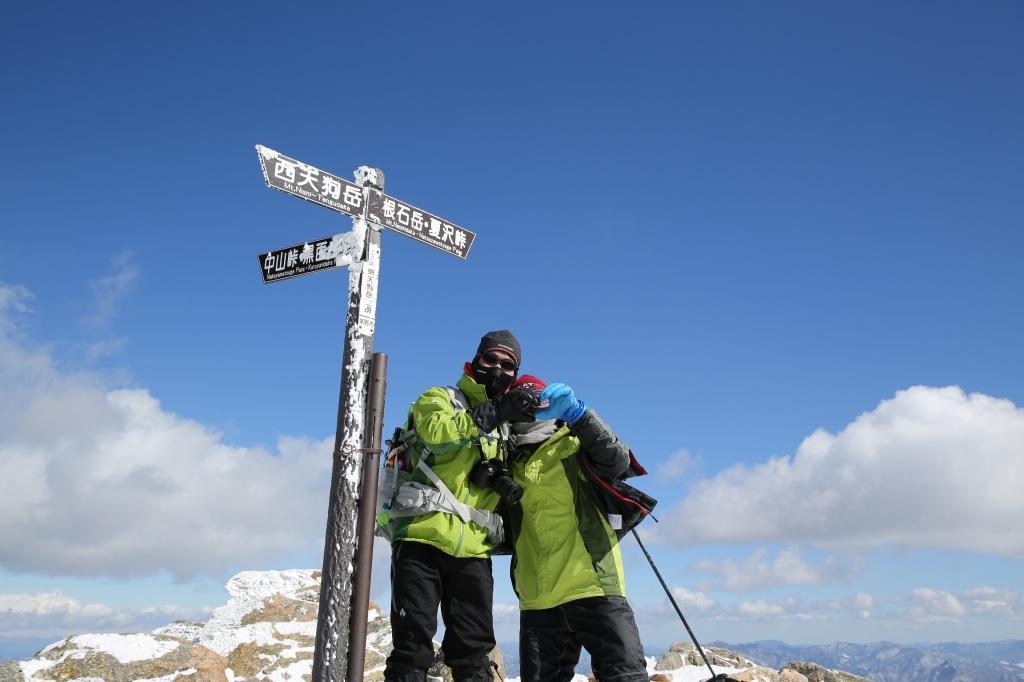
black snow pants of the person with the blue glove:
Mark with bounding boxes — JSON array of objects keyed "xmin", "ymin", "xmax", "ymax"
[{"xmin": 519, "ymin": 597, "xmax": 647, "ymax": 682}]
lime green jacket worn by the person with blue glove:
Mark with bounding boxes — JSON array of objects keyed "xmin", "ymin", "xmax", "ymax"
[{"xmin": 510, "ymin": 422, "xmax": 629, "ymax": 610}]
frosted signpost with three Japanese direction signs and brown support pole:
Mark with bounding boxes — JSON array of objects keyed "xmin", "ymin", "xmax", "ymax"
[{"xmin": 256, "ymin": 144, "xmax": 476, "ymax": 682}]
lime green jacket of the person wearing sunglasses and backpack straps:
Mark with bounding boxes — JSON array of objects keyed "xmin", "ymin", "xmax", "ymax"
[{"xmin": 392, "ymin": 374, "xmax": 501, "ymax": 559}]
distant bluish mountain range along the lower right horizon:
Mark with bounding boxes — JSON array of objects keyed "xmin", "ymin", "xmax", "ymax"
[{"xmin": 712, "ymin": 639, "xmax": 1024, "ymax": 682}]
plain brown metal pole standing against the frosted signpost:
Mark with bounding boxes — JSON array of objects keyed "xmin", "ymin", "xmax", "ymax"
[{"xmin": 346, "ymin": 353, "xmax": 387, "ymax": 682}]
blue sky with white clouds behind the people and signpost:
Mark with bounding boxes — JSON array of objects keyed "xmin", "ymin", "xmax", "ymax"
[{"xmin": 0, "ymin": 2, "xmax": 1024, "ymax": 646}]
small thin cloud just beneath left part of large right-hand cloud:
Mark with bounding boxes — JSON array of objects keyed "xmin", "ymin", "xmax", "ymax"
[{"xmin": 689, "ymin": 547, "xmax": 850, "ymax": 592}]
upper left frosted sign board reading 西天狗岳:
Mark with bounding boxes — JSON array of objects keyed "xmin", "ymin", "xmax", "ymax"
[{"xmin": 256, "ymin": 144, "xmax": 364, "ymax": 218}]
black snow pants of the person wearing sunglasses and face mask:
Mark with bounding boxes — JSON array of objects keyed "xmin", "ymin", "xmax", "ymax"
[{"xmin": 384, "ymin": 542, "xmax": 495, "ymax": 682}]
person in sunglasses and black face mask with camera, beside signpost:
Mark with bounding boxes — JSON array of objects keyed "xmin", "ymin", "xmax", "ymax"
[{"xmin": 384, "ymin": 330, "xmax": 538, "ymax": 682}]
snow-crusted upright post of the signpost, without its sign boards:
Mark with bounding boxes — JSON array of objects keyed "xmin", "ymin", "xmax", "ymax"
[{"xmin": 312, "ymin": 166, "xmax": 384, "ymax": 682}]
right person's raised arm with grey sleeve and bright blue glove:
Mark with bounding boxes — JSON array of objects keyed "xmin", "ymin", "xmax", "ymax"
[{"xmin": 536, "ymin": 384, "xmax": 630, "ymax": 478}]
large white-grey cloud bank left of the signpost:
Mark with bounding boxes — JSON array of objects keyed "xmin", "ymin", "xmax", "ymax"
[{"xmin": 0, "ymin": 285, "xmax": 332, "ymax": 579}]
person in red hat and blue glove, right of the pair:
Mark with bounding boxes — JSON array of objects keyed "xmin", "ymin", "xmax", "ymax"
[{"xmin": 509, "ymin": 375, "xmax": 648, "ymax": 682}]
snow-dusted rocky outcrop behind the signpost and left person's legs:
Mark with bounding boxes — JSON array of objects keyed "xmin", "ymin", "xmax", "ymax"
[{"xmin": 8, "ymin": 570, "xmax": 505, "ymax": 682}]
